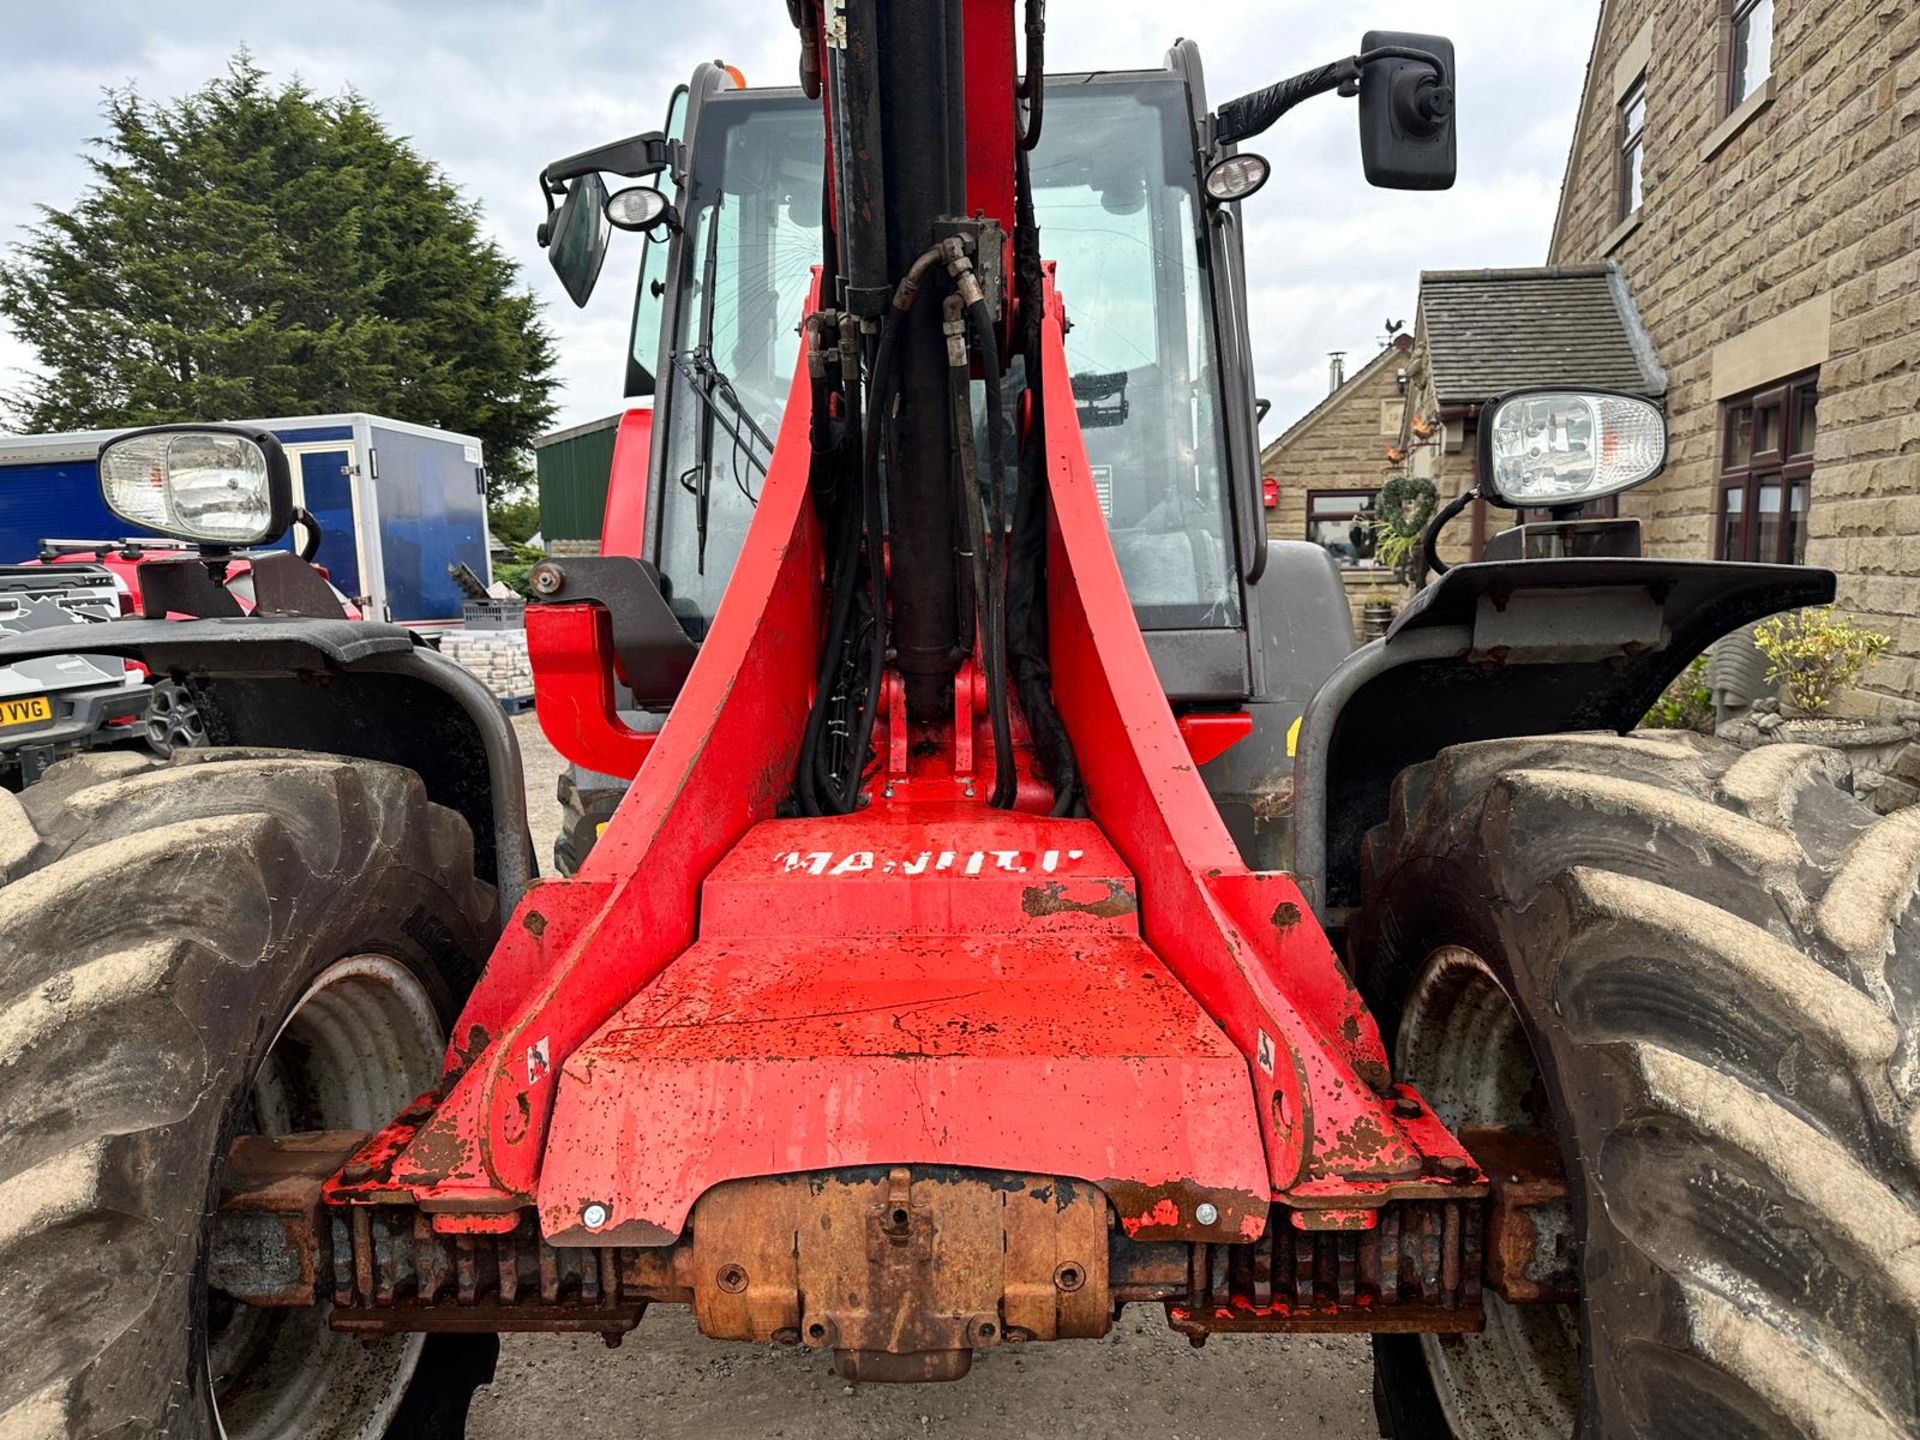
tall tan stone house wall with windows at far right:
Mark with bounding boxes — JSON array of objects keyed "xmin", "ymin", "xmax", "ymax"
[{"xmin": 1548, "ymin": 0, "xmax": 1920, "ymax": 712}]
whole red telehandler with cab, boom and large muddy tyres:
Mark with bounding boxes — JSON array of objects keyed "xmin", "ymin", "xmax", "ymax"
[{"xmin": 0, "ymin": 0, "xmax": 1920, "ymax": 1440}]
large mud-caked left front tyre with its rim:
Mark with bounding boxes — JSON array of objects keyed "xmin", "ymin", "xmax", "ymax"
[{"xmin": 0, "ymin": 749, "xmax": 497, "ymax": 1440}]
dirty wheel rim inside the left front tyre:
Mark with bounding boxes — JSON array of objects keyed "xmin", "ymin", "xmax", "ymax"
[{"xmin": 207, "ymin": 954, "xmax": 445, "ymax": 1440}]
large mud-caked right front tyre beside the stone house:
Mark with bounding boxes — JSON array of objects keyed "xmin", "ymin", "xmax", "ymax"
[{"xmin": 1350, "ymin": 732, "xmax": 1920, "ymax": 1440}]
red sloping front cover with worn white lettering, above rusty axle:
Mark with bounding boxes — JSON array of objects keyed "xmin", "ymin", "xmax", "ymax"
[{"xmin": 540, "ymin": 801, "xmax": 1267, "ymax": 1244}]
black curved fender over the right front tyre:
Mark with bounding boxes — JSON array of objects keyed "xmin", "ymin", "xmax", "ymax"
[{"xmin": 1294, "ymin": 559, "xmax": 1834, "ymax": 927}]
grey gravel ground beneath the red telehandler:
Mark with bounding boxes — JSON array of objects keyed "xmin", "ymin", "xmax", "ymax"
[{"xmin": 467, "ymin": 714, "xmax": 1377, "ymax": 1440}]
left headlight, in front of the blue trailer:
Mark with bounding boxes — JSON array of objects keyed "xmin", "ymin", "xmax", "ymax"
[{"xmin": 100, "ymin": 424, "xmax": 294, "ymax": 545}]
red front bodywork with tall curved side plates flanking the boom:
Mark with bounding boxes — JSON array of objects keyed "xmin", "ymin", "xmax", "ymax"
[{"xmin": 374, "ymin": 272, "xmax": 1476, "ymax": 1246}]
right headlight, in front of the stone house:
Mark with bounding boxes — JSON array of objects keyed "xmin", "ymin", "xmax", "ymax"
[{"xmin": 1480, "ymin": 390, "xmax": 1667, "ymax": 509}]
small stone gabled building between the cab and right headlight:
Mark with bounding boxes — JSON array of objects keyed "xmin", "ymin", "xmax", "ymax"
[{"xmin": 1260, "ymin": 332, "xmax": 1413, "ymax": 630}]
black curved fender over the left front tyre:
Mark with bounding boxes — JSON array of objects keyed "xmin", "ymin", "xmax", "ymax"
[{"xmin": 0, "ymin": 616, "xmax": 536, "ymax": 914}]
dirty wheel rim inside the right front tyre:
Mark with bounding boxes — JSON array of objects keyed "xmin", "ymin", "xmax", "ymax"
[{"xmin": 1394, "ymin": 947, "xmax": 1580, "ymax": 1440}]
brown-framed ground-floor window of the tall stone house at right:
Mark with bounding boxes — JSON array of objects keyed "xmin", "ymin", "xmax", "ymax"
[{"xmin": 1713, "ymin": 371, "xmax": 1820, "ymax": 564}]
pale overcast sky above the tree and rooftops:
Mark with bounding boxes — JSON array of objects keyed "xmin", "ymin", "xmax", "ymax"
[{"xmin": 0, "ymin": 0, "xmax": 1597, "ymax": 438}]
